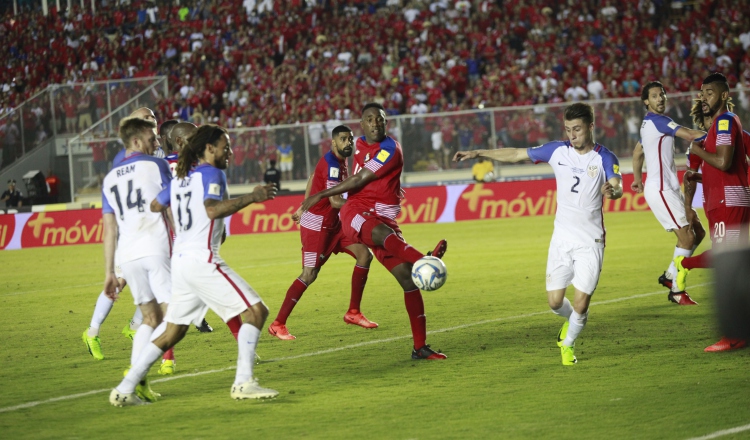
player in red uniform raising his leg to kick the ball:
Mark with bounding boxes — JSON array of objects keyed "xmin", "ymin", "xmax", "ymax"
[{"xmin": 295, "ymin": 103, "xmax": 448, "ymax": 359}]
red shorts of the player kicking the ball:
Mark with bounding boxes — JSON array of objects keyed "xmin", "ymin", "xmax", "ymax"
[{"xmin": 339, "ymin": 205, "xmax": 406, "ymax": 272}]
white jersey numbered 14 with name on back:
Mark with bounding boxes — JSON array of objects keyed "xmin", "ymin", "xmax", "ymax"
[{"xmin": 102, "ymin": 153, "xmax": 171, "ymax": 264}]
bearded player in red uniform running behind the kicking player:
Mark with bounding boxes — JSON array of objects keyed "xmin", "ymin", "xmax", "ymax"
[{"xmin": 268, "ymin": 125, "xmax": 378, "ymax": 339}]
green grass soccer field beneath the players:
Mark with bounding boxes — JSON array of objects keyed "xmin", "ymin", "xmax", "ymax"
[{"xmin": 0, "ymin": 212, "xmax": 750, "ymax": 439}]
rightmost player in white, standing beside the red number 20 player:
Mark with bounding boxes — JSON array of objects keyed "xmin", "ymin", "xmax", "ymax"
[{"xmin": 630, "ymin": 81, "xmax": 706, "ymax": 305}]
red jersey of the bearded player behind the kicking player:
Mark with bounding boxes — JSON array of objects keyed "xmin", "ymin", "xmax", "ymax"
[{"xmin": 300, "ymin": 151, "xmax": 349, "ymax": 231}]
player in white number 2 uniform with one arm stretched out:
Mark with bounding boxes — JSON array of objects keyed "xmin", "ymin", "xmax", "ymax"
[{"xmin": 453, "ymin": 103, "xmax": 622, "ymax": 365}]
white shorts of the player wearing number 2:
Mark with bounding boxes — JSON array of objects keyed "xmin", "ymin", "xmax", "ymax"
[{"xmin": 547, "ymin": 240, "xmax": 604, "ymax": 295}]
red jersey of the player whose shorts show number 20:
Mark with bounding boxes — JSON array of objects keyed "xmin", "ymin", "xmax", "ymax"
[{"xmin": 703, "ymin": 112, "xmax": 750, "ymax": 211}]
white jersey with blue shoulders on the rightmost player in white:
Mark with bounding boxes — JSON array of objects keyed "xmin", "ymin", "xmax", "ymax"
[{"xmin": 641, "ymin": 112, "xmax": 681, "ymax": 191}]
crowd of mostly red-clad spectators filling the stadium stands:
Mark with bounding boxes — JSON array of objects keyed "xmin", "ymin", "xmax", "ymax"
[{"xmin": 0, "ymin": 0, "xmax": 750, "ymax": 178}]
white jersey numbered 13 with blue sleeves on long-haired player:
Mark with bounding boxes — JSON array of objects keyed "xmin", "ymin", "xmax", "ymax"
[{"xmin": 157, "ymin": 164, "xmax": 229, "ymax": 263}]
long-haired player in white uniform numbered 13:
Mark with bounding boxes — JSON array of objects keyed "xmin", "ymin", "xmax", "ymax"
[{"xmin": 109, "ymin": 125, "xmax": 278, "ymax": 406}]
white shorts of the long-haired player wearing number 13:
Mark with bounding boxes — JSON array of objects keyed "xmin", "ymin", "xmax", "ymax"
[{"xmin": 164, "ymin": 254, "xmax": 261, "ymax": 325}]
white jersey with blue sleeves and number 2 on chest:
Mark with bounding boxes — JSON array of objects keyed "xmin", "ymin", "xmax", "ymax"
[{"xmin": 527, "ymin": 141, "xmax": 622, "ymax": 247}]
